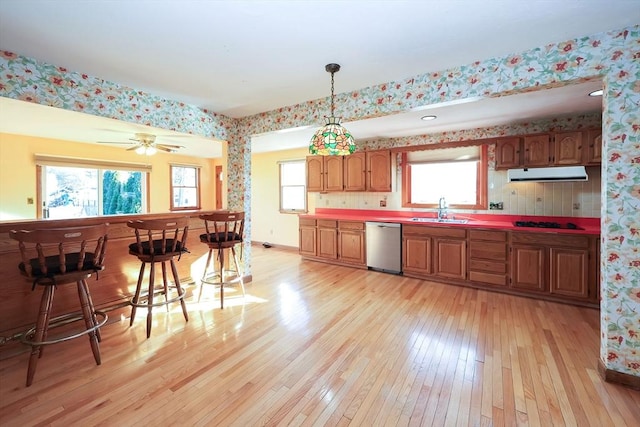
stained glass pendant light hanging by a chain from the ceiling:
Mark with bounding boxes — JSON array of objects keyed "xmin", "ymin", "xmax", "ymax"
[{"xmin": 309, "ymin": 64, "xmax": 356, "ymax": 156}]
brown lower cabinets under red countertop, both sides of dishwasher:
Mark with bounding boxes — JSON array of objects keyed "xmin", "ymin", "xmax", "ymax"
[{"xmin": 299, "ymin": 218, "xmax": 599, "ymax": 306}]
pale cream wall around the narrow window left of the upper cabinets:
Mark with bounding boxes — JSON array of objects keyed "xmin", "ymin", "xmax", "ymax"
[{"xmin": 251, "ymin": 147, "xmax": 315, "ymax": 248}]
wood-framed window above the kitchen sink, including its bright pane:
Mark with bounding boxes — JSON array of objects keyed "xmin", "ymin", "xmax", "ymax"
[{"xmin": 402, "ymin": 145, "xmax": 487, "ymax": 209}]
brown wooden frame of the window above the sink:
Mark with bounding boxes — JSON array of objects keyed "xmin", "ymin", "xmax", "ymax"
[{"xmin": 401, "ymin": 144, "xmax": 489, "ymax": 210}]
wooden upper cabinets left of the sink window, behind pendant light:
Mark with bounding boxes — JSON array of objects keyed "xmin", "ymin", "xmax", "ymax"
[{"xmin": 307, "ymin": 150, "xmax": 391, "ymax": 192}]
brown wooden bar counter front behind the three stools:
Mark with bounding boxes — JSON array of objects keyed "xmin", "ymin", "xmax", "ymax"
[{"xmin": 0, "ymin": 211, "xmax": 225, "ymax": 346}]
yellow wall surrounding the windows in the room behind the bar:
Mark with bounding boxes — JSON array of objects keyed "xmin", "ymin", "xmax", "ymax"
[{"xmin": 0, "ymin": 133, "xmax": 219, "ymax": 220}]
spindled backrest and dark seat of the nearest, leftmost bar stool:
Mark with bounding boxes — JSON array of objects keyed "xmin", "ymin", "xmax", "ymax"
[{"xmin": 9, "ymin": 224, "xmax": 108, "ymax": 283}]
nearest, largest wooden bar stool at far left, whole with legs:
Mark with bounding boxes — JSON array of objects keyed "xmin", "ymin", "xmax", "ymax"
[{"xmin": 9, "ymin": 224, "xmax": 107, "ymax": 387}]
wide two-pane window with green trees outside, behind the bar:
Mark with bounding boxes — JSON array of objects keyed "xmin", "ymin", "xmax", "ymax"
[{"xmin": 40, "ymin": 165, "xmax": 147, "ymax": 218}]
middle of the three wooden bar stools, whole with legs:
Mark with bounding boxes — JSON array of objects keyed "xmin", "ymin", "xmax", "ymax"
[{"xmin": 127, "ymin": 217, "xmax": 189, "ymax": 338}]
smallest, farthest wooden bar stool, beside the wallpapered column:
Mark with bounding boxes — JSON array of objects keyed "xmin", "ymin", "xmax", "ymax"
[{"xmin": 198, "ymin": 211, "xmax": 245, "ymax": 308}]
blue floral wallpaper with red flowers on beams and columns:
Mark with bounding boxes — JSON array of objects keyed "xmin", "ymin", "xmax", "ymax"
[{"xmin": 0, "ymin": 26, "xmax": 640, "ymax": 376}]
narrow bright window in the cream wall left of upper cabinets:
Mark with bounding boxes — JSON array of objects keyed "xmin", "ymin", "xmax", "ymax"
[{"xmin": 280, "ymin": 160, "xmax": 307, "ymax": 213}]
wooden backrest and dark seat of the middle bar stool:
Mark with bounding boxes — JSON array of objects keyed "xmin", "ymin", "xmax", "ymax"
[{"xmin": 127, "ymin": 217, "xmax": 189, "ymax": 256}]
